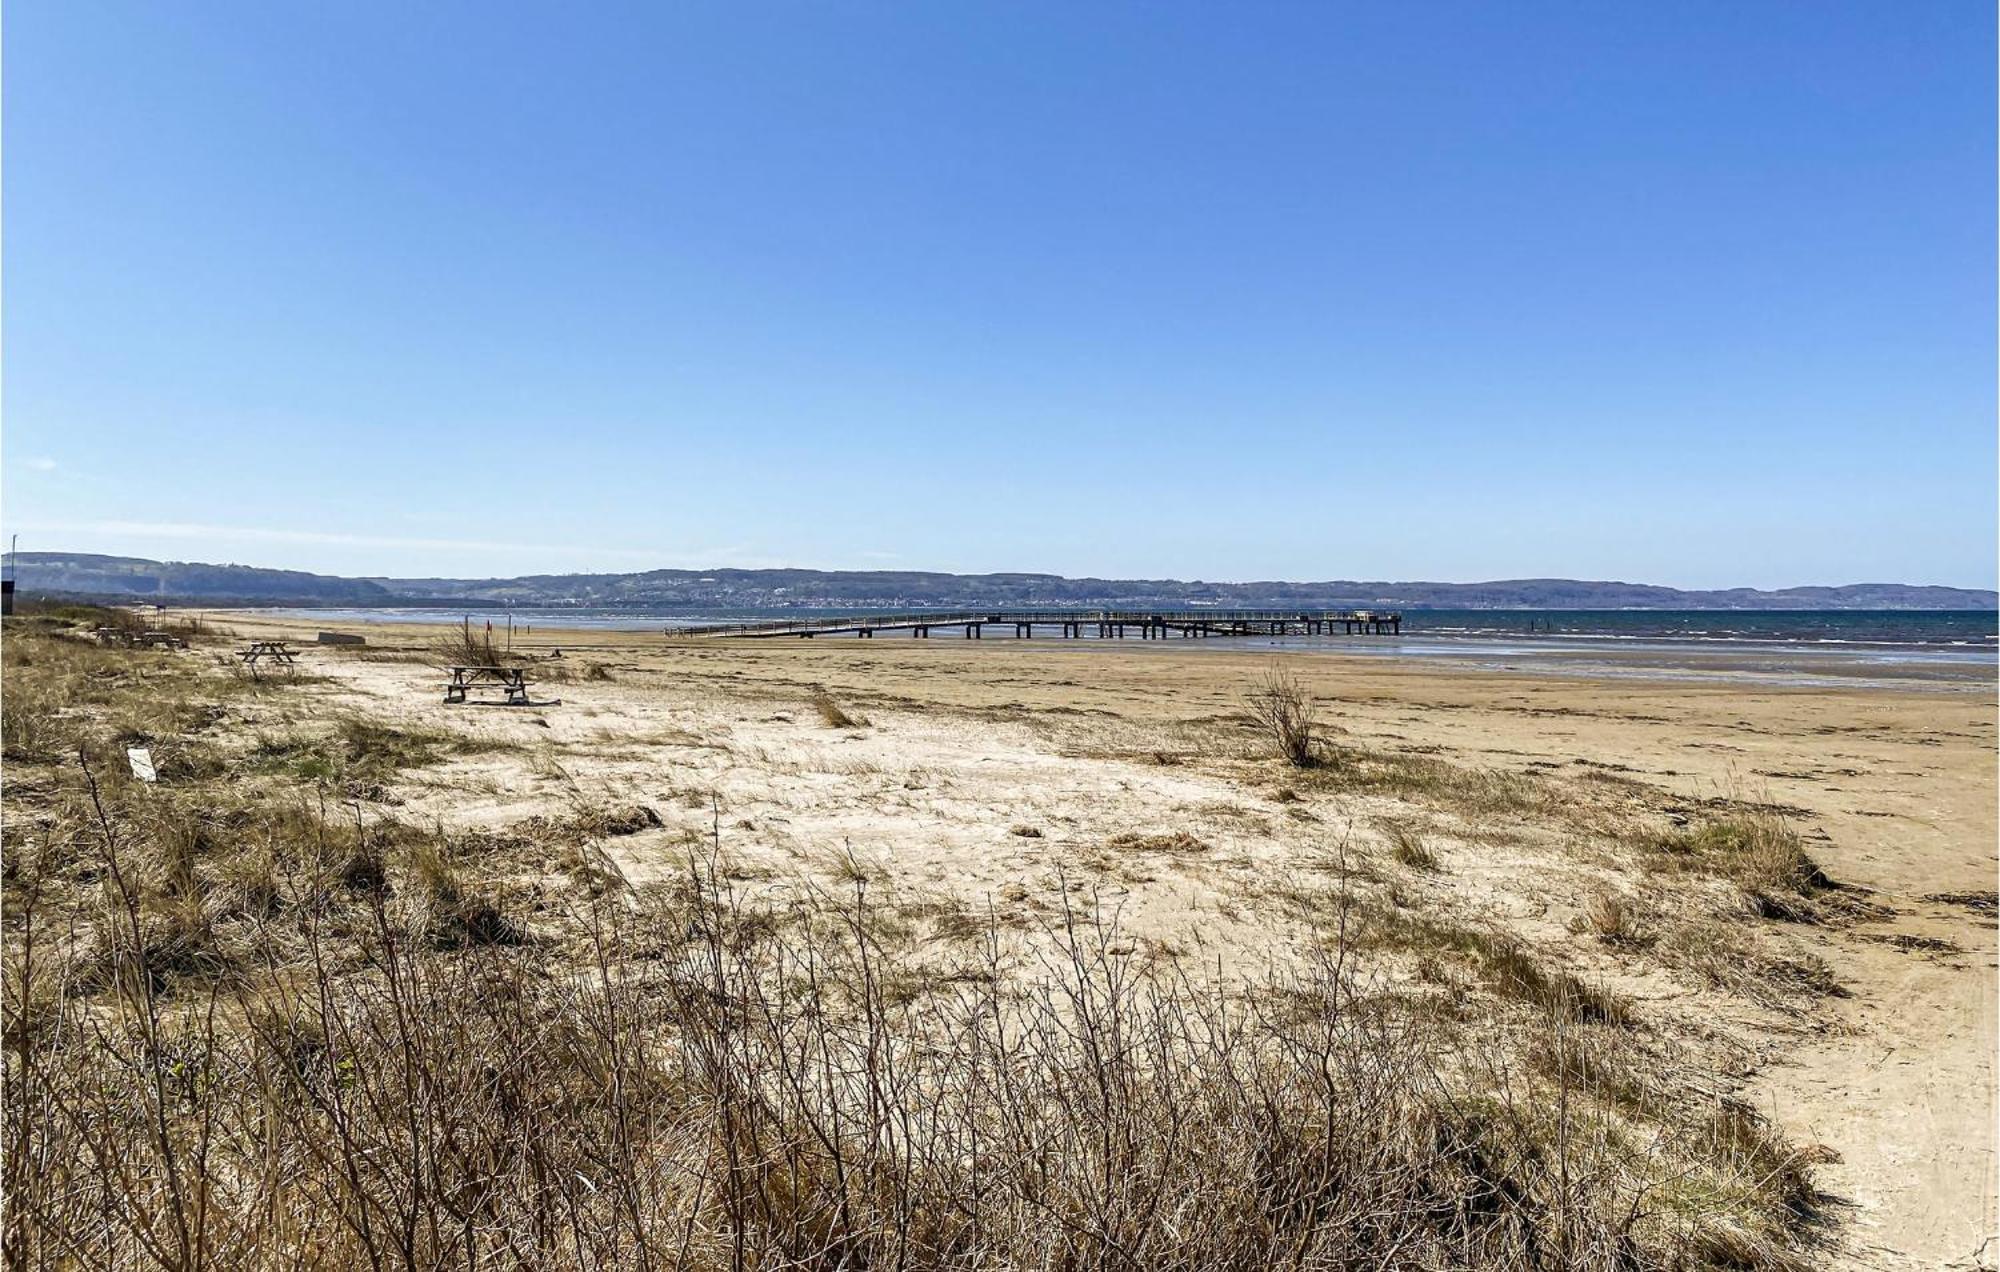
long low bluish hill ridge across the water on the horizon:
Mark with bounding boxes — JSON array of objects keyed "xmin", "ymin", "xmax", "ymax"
[{"xmin": 16, "ymin": 552, "xmax": 2000, "ymax": 610}]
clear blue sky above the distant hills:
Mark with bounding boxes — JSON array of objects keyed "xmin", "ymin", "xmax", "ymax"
[{"xmin": 0, "ymin": 0, "xmax": 1996, "ymax": 586}]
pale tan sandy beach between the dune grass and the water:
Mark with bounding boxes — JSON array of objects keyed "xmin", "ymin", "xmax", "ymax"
[{"xmin": 211, "ymin": 614, "xmax": 2000, "ymax": 1268}]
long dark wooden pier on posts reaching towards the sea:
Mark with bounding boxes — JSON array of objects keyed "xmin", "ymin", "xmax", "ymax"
[{"xmin": 666, "ymin": 610, "xmax": 1402, "ymax": 640}]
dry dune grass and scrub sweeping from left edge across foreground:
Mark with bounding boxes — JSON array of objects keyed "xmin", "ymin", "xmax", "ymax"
[{"xmin": 0, "ymin": 620, "xmax": 1814, "ymax": 1270}]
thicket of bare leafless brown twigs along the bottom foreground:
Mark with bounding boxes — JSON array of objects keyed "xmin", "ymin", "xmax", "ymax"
[{"xmin": 6, "ymin": 828, "xmax": 1796, "ymax": 1268}]
